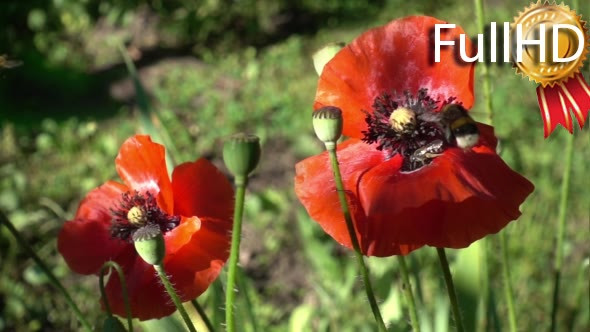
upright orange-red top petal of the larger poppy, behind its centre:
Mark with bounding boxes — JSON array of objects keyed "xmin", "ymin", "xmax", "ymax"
[{"xmin": 314, "ymin": 16, "xmax": 474, "ymax": 138}]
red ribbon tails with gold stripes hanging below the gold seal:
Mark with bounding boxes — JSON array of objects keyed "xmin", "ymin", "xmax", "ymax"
[{"xmin": 537, "ymin": 73, "xmax": 590, "ymax": 138}]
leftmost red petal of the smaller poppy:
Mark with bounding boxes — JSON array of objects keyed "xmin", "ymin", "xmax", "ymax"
[{"xmin": 57, "ymin": 181, "xmax": 131, "ymax": 274}]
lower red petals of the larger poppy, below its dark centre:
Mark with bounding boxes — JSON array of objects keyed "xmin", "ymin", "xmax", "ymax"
[{"xmin": 295, "ymin": 125, "xmax": 534, "ymax": 256}]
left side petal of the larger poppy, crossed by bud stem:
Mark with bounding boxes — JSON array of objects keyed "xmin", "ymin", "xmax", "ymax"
[{"xmin": 295, "ymin": 139, "xmax": 419, "ymax": 255}]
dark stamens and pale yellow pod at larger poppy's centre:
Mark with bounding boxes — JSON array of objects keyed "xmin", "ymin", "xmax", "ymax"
[{"xmin": 363, "ymin": 89, "xmax": 455, "ymax": 172}]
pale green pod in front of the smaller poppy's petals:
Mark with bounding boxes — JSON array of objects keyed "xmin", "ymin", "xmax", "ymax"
[{"xmin": 133, "ymin": 225, "xmax": 166, "ymax": 265}]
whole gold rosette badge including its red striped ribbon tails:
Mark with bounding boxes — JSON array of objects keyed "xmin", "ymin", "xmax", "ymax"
[{"xmin": 511, "ymin": 1, "xmax": 590, "ymax": 137}]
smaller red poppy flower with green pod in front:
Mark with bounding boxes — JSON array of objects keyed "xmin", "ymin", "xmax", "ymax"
[{"xmin": 57, "ymin": 135, "xmax": 233, "ymax": 320}]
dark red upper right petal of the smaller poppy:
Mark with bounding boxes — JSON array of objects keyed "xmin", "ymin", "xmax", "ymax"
[{"xmin": 172, "ymin": 158, "xmax": 234, "ymax": 220}]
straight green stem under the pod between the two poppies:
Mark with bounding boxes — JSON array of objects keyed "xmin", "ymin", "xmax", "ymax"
[{"xmin": 225, "ymin": 176, "xmax": 247, "ymax": 332}]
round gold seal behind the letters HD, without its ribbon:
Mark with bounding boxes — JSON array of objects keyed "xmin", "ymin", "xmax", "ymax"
[{"xmin": 511, "ymin": 1, "xmax": 590, "ymax": 87}]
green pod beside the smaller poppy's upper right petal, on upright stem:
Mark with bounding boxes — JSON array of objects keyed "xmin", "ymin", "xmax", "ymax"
[{"xmin": 223, "ymin": 133, "xmax": 260, "ymax": 178}]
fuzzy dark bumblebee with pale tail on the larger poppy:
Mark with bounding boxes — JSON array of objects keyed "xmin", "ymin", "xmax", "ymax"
[{"xmin": 440, "ymin": 104, "xmax": 479, "ymax": 149}]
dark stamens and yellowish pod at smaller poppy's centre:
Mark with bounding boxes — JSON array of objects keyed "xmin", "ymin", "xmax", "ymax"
[{"xmin": 111, "ymin": 191, "xmax": 180, "ymax": 242}]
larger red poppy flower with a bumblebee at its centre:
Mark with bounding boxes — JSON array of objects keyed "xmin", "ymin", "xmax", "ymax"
[{"xmin": 295, "ymin": 16, "xmax": 533, "ymax": 256}]
